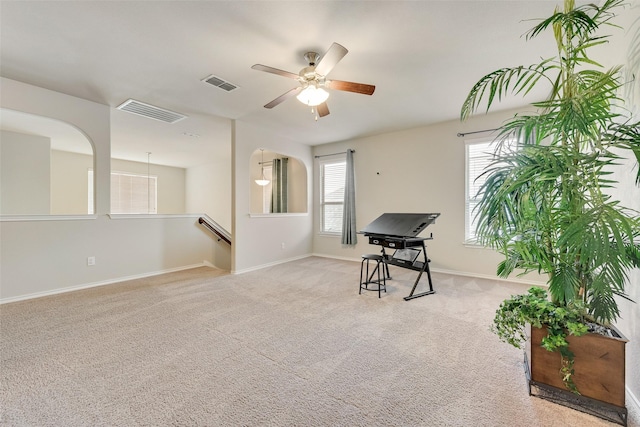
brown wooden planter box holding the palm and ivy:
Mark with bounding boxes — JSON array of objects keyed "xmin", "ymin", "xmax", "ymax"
[{"xmin": 525, "ymin": 326, "xmax": 628, "ymax": 425}]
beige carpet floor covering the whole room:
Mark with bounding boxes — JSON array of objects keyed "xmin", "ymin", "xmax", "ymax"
[{"xmin": 0, "ymin": 257, "xmax": 640, "ymax": 427}]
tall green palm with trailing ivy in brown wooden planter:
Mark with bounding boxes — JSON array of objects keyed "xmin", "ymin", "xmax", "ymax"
[{"xmin": 461, "ymin": 0, "xmax": 640, "ymax": 422}]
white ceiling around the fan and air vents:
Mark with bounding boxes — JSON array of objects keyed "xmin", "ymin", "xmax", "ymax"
[{"xmin": 0, "ymin": 0, "xmax": 620, "ymax": 167}]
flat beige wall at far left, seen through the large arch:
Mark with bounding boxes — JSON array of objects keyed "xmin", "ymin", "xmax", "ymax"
[{"xmin": 0, "ymin": 131, "xmax": 51, "ymax": 215}]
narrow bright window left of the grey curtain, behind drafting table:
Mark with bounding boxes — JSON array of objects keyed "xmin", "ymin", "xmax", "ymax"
[{"xmin": 320, "ymin": 157, "xmax": 347, "ymax": 234}]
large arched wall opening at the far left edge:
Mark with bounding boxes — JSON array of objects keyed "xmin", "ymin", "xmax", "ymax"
[{"xmin": 0, "ymin": 108, "xmax": 95, "ymax": 216}]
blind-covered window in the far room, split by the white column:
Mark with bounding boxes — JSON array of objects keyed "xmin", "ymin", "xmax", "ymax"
[{"xmin": 89, "ymin": 170, "xmax": 158, "ymax": 214}]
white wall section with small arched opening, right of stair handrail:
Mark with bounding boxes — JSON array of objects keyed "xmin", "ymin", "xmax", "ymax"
[{"xmin": 232, "ymin": 120, "xmax": 312, "ymax": 272}]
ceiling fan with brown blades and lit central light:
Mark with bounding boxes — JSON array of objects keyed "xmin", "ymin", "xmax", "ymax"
[{"xmin": 251, "ymin": 43, "xmax": 376, "ymax": 120}]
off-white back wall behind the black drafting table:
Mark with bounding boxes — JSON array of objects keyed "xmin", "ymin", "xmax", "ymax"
[{"xmin": 313, "ymin": 107, "xmax": 546, "ymax": 283}]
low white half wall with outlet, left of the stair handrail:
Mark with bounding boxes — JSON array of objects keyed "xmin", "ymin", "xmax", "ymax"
[{"xmin": 0, "ymin": 215, "xmax": 214, "ymax": 302}]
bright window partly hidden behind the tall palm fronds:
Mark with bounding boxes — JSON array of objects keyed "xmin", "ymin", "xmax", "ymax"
[{"xmin": 464, "ymin": 139, "xmax": 516, "ymax": 244}]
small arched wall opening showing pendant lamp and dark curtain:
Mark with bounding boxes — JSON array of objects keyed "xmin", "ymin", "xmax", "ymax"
[{"xmin": 249, "ymin": 148, "xmax": 308, "ymax": 215}]
